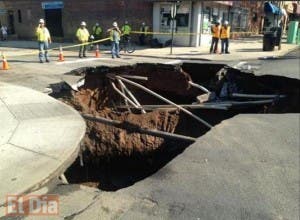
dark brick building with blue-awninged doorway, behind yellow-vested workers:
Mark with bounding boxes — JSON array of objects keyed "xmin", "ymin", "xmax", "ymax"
[{"xmin": 0, "ymin": 0, "xmax": 152, "ymax": 40}]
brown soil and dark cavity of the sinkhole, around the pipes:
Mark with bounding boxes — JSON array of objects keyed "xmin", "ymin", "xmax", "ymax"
[{"xmin": 53, "ymin": 63, "xmax": 300, "ymax": 190}]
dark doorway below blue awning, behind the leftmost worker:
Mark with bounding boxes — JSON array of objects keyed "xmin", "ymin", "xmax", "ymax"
[{"xmin": 45, "ymin": 9, "xmax": 64, "ymax": 37}]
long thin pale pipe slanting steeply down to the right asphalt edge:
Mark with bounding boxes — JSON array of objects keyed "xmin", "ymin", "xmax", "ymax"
[{"xmin": 116, "ymin": 76, "xmax": 213, "ymax": 128}]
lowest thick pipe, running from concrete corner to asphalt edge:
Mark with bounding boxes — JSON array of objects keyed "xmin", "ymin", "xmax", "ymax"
[{"xmin": 81, "ymin": 114, "xmax": 196, "ymax": 142}]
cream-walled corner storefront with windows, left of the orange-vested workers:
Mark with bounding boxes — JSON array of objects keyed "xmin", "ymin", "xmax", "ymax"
[{"xmin": 153, "ymin": 0, "xmax": 232, "ymax": 47}]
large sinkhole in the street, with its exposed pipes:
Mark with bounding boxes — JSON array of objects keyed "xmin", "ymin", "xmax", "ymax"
[{"xmin": 51, "ymin": 63, "xmax": 300, "ymax": 191}]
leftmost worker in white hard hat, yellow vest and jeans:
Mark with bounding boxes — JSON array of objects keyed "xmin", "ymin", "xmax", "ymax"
[{"xmin": 36, "ymin": 18, "xmax": 51, "ymax": 63}]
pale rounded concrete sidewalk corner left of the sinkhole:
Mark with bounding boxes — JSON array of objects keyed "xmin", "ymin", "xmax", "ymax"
[{"xmin": 0, "ymin": 83, "xmax": 86, "ymax": 208}]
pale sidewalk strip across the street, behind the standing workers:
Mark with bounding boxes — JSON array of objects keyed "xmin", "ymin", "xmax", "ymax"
[{"xmin": 0, "ymin": 37, "xmax": 299, "ymax": 61}]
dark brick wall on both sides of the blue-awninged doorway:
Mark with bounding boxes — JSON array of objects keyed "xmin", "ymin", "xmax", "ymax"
[{"xmin": 4, "ymin": 0, "xmax": 152, "ymax": 40}]
